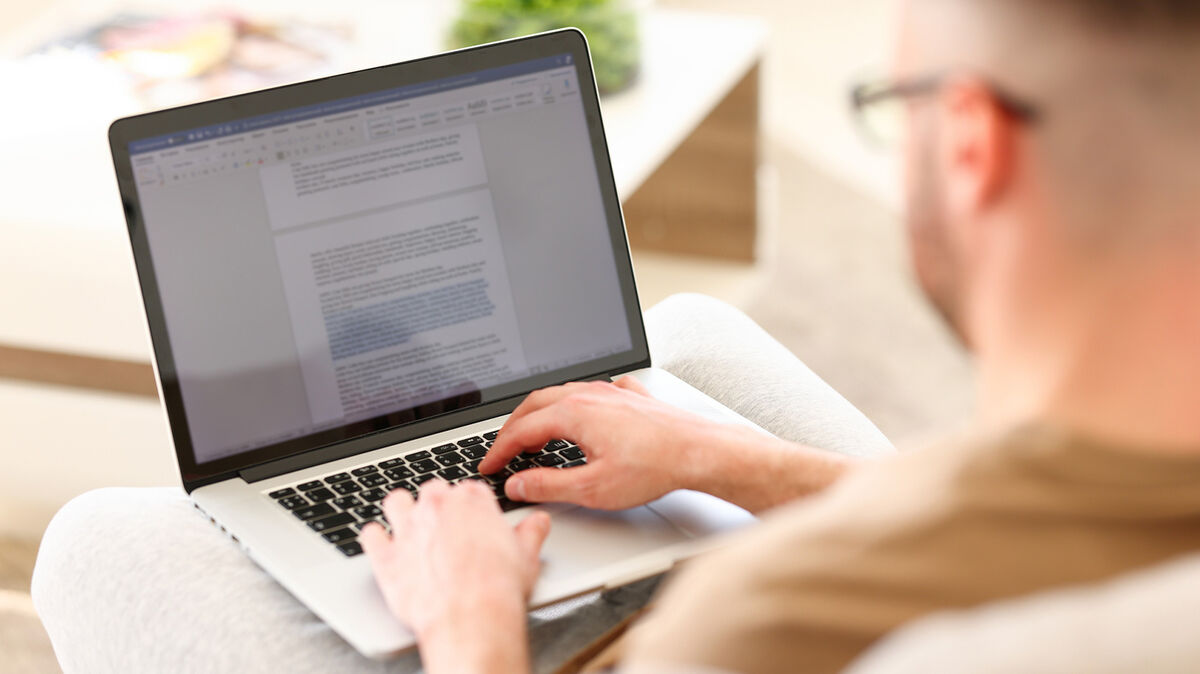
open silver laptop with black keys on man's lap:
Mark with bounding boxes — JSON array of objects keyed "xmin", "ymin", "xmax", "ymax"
[{"xmin": 109, "ymin": 29, "xmax": 754, "ymax": 658}]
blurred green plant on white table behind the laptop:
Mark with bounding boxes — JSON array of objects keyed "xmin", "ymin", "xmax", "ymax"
[{"xmin": 450, "ymin": 0, "xmax": 640, "ymax": 94}]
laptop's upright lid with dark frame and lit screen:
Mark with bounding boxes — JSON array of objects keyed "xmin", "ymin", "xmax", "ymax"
[{"xmin": 109, "ymin": 29, "xmax": 649, "ymax": 491}]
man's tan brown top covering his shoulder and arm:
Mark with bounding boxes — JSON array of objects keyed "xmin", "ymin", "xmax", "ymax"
[{"xmin": 620, "ymin": 428, "xmax": 1200, "ymax": 672}]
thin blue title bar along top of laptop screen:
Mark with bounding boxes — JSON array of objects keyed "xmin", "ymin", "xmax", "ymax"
[{"xmin": 130, "ymin": 54, "xmax": 571, "ymax": 155}]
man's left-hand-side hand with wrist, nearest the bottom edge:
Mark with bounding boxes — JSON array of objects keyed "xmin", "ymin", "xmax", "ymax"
[{"xmin": 360, "ymin": 480, "xmax": 550, "ymax": 672}]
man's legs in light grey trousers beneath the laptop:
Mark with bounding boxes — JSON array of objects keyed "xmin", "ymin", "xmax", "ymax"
[{"xmin": 34, "ymin": 295, "xmax": 890, "ymax": 672}]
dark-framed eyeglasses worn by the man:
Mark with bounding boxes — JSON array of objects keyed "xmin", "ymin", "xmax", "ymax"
[{"xmin": 850, "ymin": 73, "xmax": 1040, "ymax": 148}]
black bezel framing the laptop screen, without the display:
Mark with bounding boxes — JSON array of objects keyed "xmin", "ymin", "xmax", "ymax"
[{"xmin": 108, "ymin": 29, "xmax": 650, "ymax": 493}]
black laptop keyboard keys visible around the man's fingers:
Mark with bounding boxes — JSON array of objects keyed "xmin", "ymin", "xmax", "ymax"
[{"xmin": 268, "ymin": 431, "xmax": 584, "ymax": 556}]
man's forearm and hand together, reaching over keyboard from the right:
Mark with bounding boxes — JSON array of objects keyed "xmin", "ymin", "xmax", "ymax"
[{"xmin": 479, "ymin": 377, "xmax": 854, "ymax": 512}]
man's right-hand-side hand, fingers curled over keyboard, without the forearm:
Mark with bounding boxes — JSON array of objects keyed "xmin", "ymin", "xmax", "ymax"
[{"xmin": 479, "ymin": 377, "xmax": 718, "ymax": 510}]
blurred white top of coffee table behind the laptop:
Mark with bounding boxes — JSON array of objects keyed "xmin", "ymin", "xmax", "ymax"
[{"xmin": 0, "ymin": 2, "xmax": 766, "ymax": 361}]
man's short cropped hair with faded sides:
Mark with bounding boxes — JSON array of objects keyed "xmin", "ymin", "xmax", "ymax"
[{"xmin": 913, "ymin": 0, "xmax": 1200, "ymax": 236}]
